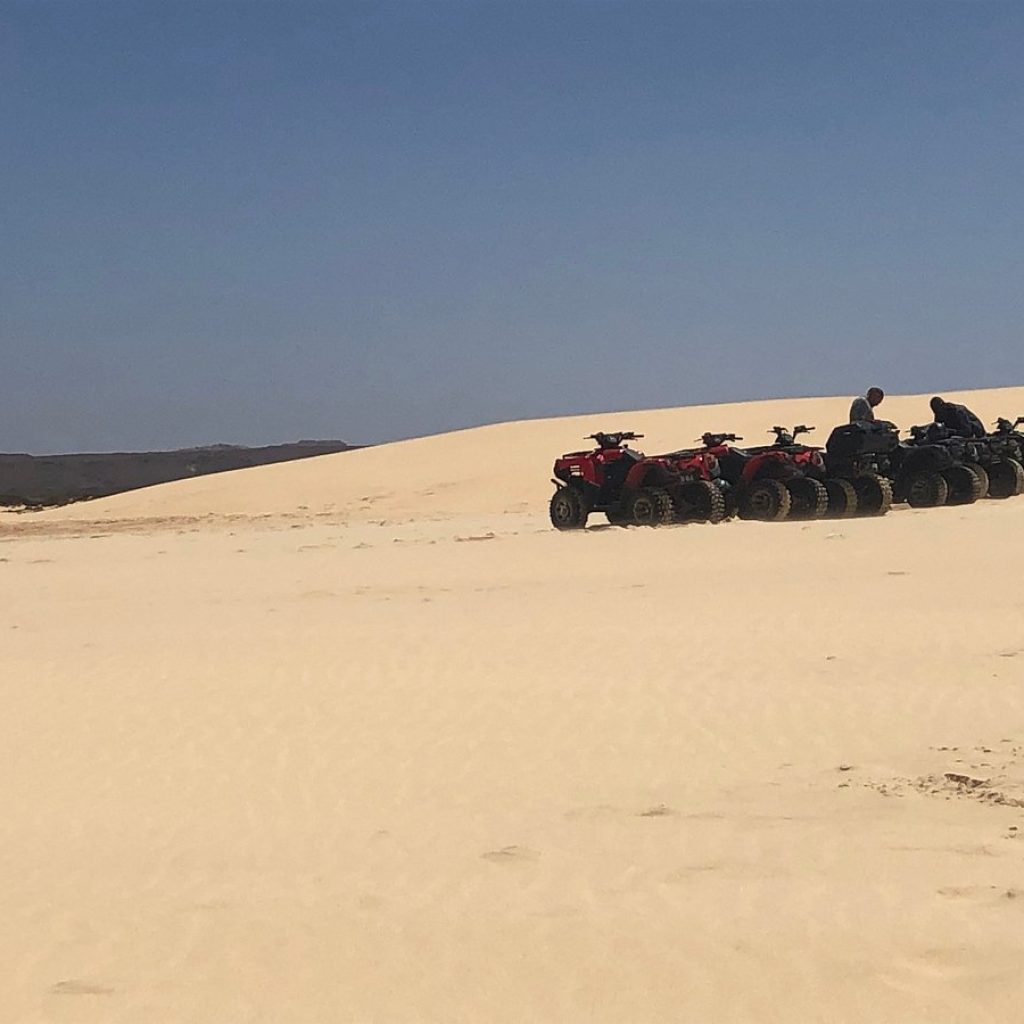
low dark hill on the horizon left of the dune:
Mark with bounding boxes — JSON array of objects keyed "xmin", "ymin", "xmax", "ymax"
[{"xmin": 0, "ymin": 441, "xmax": 357, "ymax": 507}]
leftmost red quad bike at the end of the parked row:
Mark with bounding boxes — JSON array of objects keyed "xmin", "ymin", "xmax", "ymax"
[{"xmin": 550, "ymin": 431, "xmax": 726, "ymax": 529}]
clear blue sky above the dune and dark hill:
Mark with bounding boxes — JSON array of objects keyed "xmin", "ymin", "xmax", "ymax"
[{"xmin": 0, "ymin": 0, "xmax": 1024, "ymax": 452}]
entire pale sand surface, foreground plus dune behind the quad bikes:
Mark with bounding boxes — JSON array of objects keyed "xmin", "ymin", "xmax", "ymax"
[{"xmin": 0, "ymin": 388, "xmax": 1024, "ymax": 1024}]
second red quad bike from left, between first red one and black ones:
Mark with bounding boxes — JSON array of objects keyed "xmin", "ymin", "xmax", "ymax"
[{"xmin": 697, "ymin": 427, "xmax": 828, "ymax": 522}]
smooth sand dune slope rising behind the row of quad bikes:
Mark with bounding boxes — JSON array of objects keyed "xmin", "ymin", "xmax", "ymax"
[{"xmin": 36, "ymin": 388, "xmax": 1024, "ymax": 522}]
